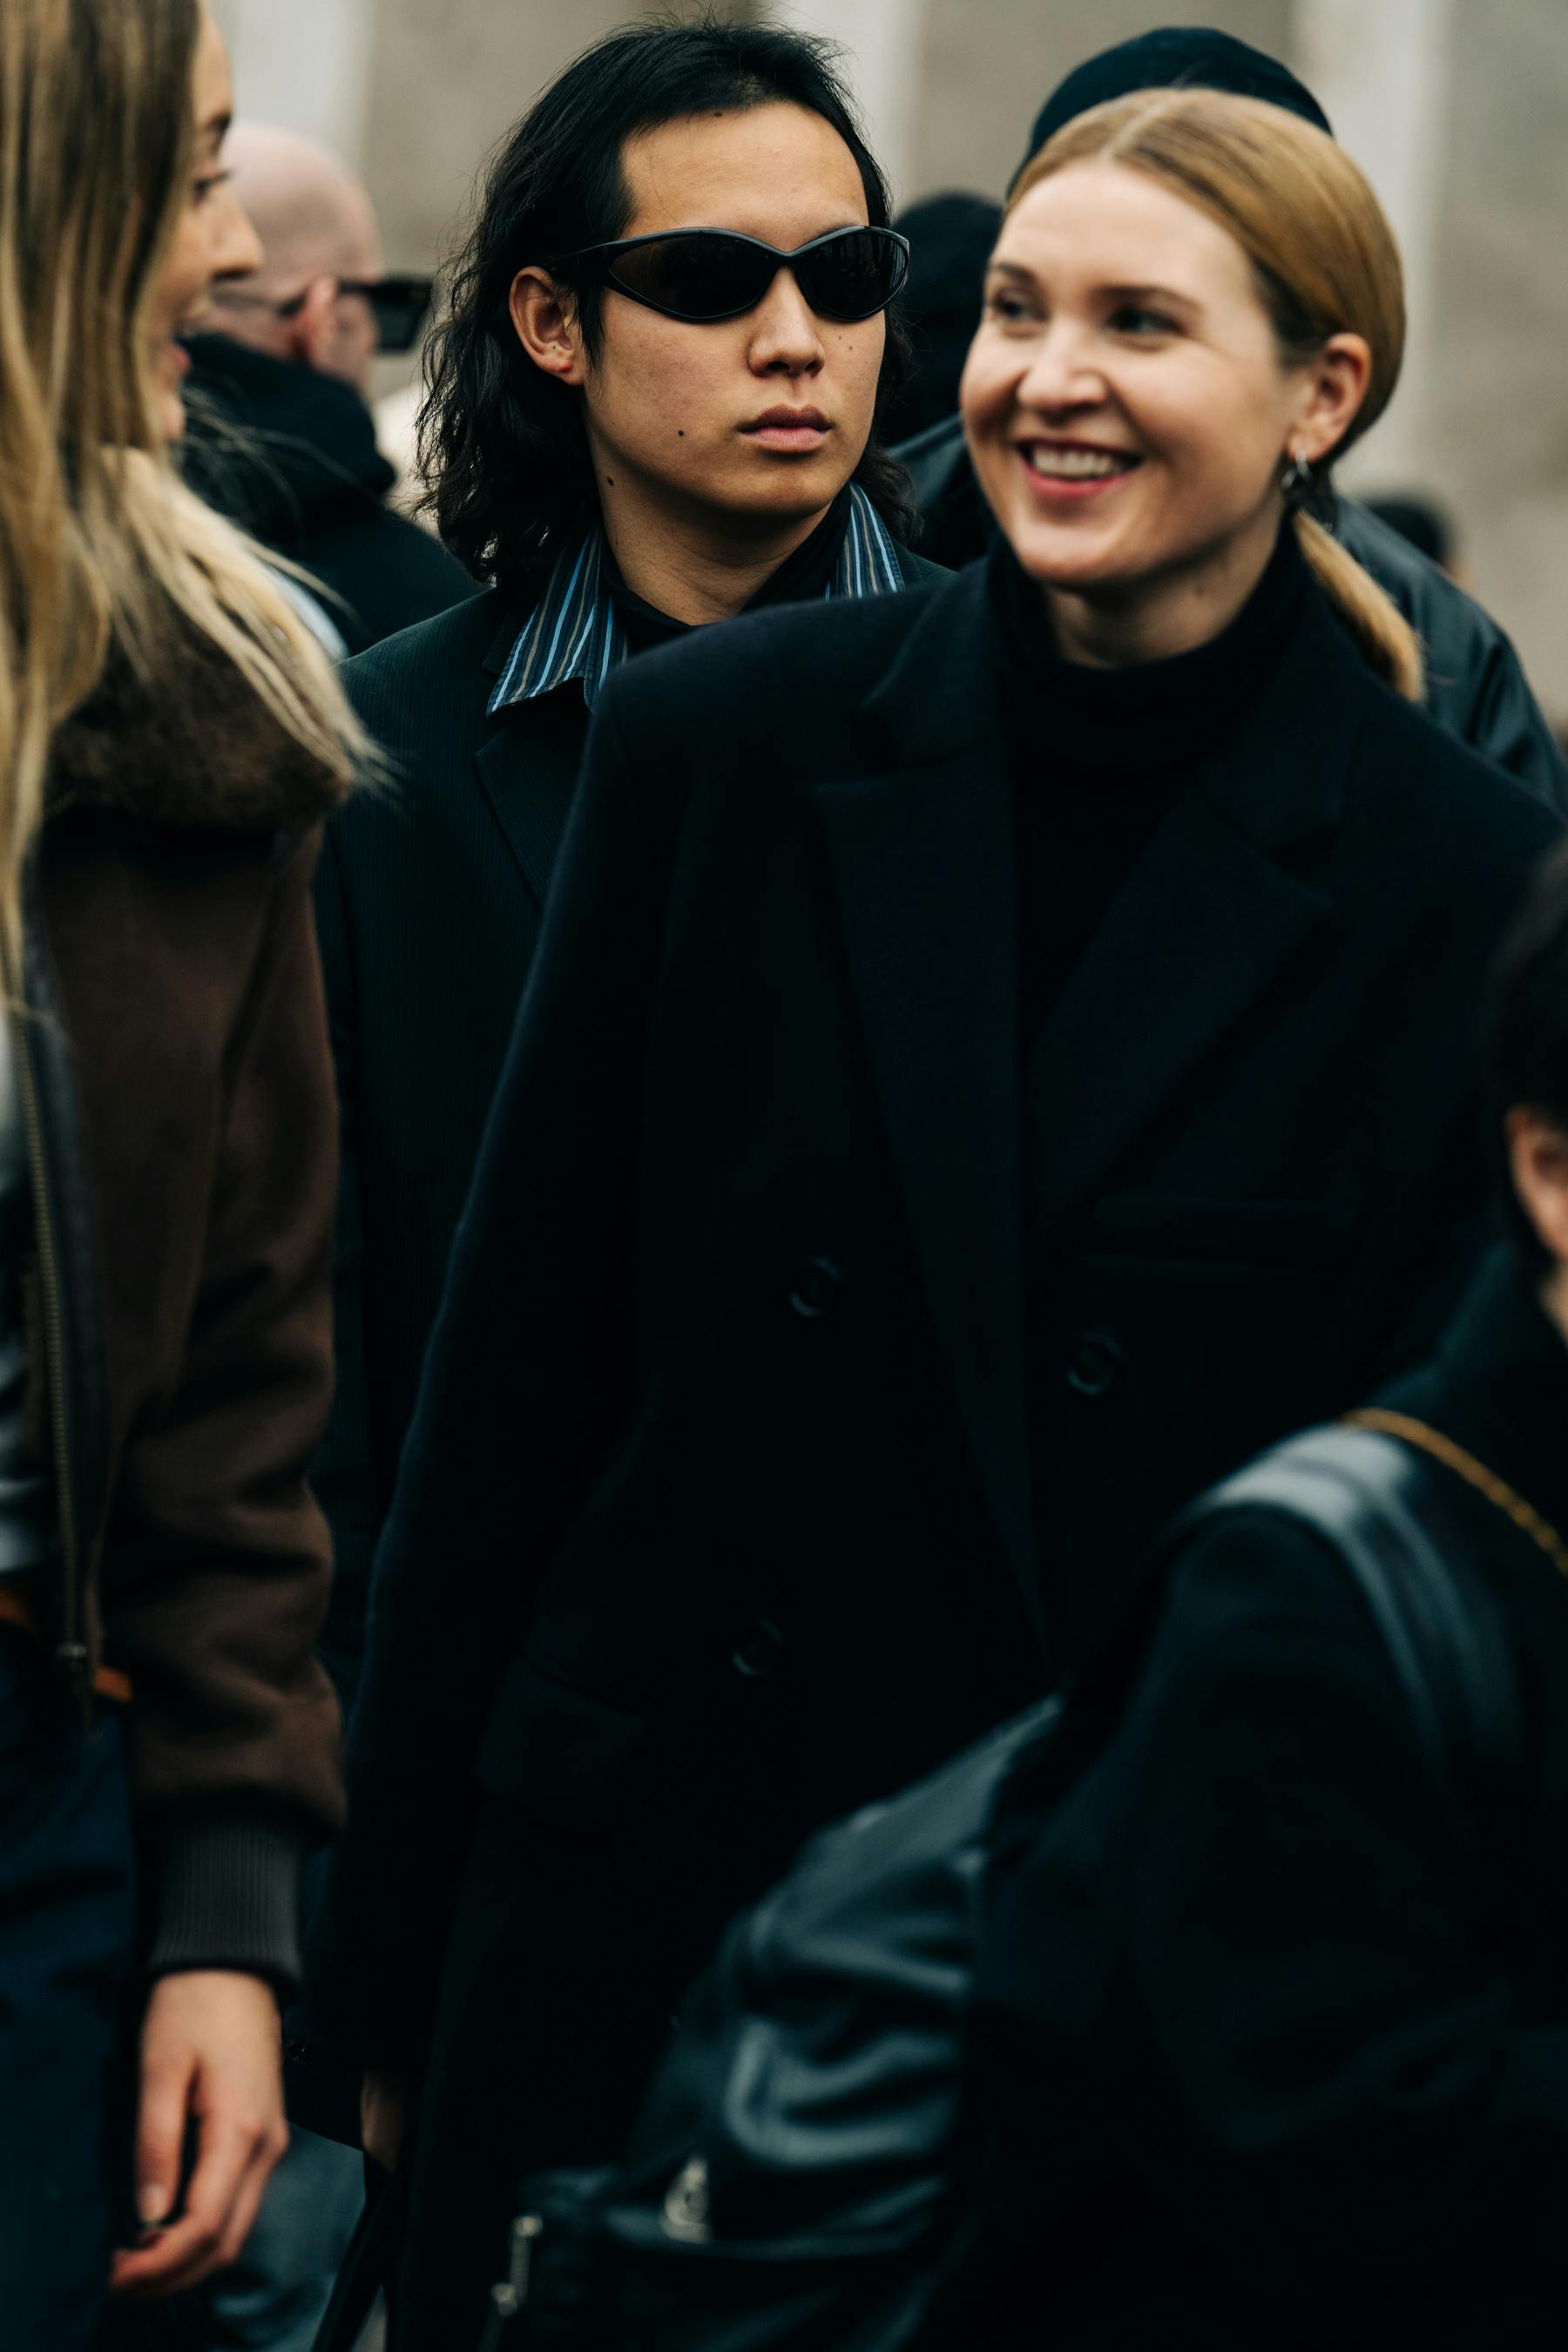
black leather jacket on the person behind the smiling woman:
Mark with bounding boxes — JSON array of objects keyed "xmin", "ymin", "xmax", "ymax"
[{"xmin": 896, "ymin": 416, "xmax": 1568, "ymax": 816}]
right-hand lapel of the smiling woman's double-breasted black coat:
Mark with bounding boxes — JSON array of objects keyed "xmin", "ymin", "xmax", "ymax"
[{"xmin": 1023, "ymin": 588, "xmax": 1369, "ymax": 1284}]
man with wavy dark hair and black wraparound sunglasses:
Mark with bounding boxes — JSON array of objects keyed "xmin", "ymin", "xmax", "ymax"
[{"xmin": 317, "ymin": 24, "xmax": 938, "ymax": 1731}]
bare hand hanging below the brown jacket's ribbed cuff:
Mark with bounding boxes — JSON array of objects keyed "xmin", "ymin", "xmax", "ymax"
[{"xmin": 111, "ymin": 1969, "xmax": 289, "ymax": 2295}]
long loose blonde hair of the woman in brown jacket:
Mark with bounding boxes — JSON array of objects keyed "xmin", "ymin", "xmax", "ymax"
[{"xmin": 0, "ymin": 0, "xmax": 364, "ymax": 950}]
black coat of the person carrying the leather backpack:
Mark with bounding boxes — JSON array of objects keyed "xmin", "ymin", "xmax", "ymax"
[{"xmin": 922, "ymin": 1260, "xmax": 1568, "ymax": 2352}]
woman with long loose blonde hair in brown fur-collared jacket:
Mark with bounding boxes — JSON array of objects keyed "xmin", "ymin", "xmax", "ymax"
[{"xmin": 0, "ymin": 0, "xmax": 360, "ymax": 2352}]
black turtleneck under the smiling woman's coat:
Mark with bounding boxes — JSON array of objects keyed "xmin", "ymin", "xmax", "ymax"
[{"xmin": 987, "ymin": 530, "xmax": 1312, "ymax": 1054}]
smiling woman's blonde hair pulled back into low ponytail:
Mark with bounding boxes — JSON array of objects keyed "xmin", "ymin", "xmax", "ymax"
[{"xmin": 1009, "ymin": 90, "xmax": 1424, "ymax": 703}]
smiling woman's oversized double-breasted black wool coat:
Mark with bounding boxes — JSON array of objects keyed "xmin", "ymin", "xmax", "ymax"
[{"xmin": 322, "ymin": 559, "xmax": 1557, "ymax": 2342}]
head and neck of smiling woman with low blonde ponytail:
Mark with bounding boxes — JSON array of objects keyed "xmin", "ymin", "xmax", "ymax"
[{"xmin": 962, "ymin": 90, "xmax": 1424, "ymax": 703}]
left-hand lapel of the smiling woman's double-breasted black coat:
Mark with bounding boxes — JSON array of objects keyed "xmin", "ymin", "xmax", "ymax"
[{"xmin": 815, "ymin": 591, "xmax": 1039, "ymax": 1623}]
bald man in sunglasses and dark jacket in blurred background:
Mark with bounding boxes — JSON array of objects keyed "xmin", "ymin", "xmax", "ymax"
[{"xmin": 183, "ymin": 122, "xmax": 475, "ymax": 654}]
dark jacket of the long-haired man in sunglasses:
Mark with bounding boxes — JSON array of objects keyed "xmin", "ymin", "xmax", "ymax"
[{"xmin": 315, "ymin": 553, "xmax": 943, "ymax": 1693}]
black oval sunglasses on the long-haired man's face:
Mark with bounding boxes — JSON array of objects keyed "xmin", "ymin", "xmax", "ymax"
[{"xmin": 559, "ymin": 228, "xmax": 909, "ymax": 327}]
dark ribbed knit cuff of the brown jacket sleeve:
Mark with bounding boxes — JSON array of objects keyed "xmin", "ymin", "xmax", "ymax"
[{"xmin": 148, "ymin": 1800, "xmax": 308, "ymax": 1999}]
